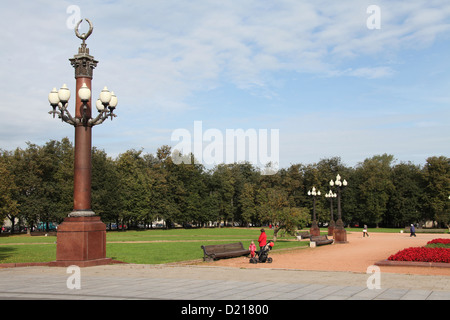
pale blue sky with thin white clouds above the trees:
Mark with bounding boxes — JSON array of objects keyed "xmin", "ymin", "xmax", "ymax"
[{"xmin": 0, "ymin": 0, "xmax": 450, "ymax": 167}]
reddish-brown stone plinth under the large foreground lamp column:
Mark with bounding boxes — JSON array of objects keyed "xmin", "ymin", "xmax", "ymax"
[{"xmin": 50, "ymin": 216, "xmax": 112, "ymax": 267}]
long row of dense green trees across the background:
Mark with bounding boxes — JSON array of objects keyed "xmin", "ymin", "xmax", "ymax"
[{"xmin": 0, "ymin": 138, "xmax": 450, "ymax": 231}]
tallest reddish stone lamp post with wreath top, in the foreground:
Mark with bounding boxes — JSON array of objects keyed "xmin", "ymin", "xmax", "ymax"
[{"xmin": 48, "ymin": 19, "xmax": 117, "ymax": 267}]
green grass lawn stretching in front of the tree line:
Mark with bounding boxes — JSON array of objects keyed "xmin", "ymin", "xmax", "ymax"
[{"xmin": 0, "ymin": 228, "xmax": 426, "ymax": 264}]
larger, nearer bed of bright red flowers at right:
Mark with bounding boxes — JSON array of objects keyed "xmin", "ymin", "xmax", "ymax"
[{"xmin": 388, "ymin": 247, "xmax": 450, "ymax": 263}]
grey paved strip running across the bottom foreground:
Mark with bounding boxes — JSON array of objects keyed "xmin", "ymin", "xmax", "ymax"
[{"xmin": 0, "ymin": 264, "xmax": 450, "ymax": 301}]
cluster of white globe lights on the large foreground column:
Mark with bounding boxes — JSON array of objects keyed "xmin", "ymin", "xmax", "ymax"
[{"xmin": 48, "ymin": 83, "xmax": 118, "ymax": 126}]
